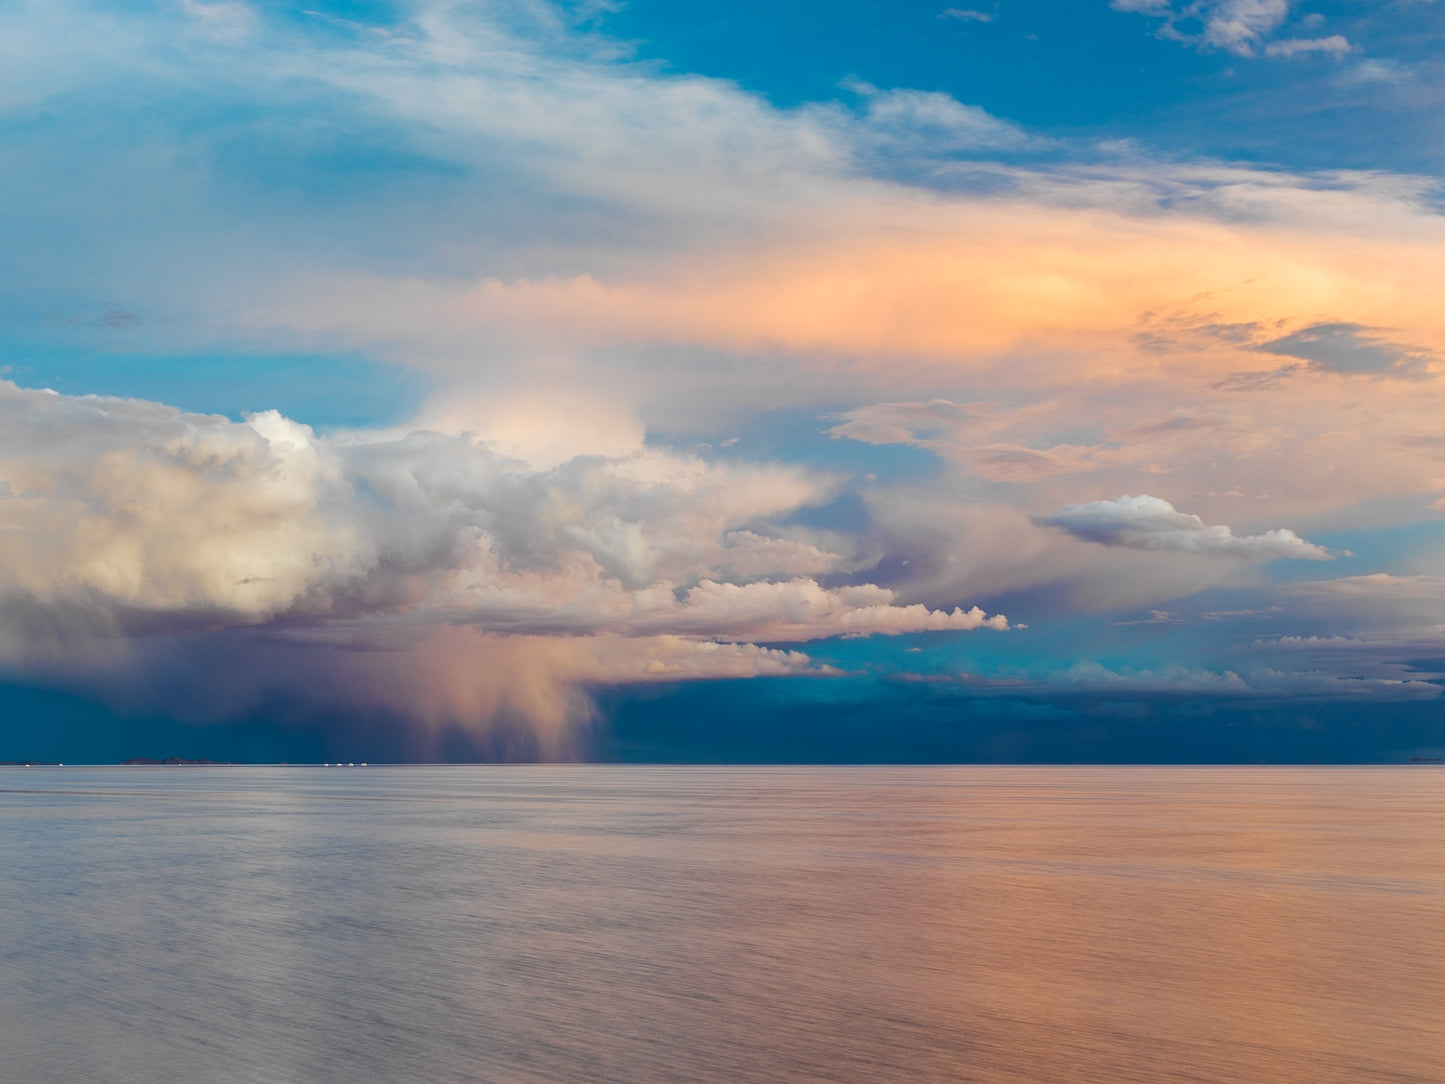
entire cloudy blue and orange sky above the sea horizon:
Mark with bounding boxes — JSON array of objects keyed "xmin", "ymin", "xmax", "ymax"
[{"xmin": 0, "ymin": 0, "xmax": 1445, "ymax": 763}]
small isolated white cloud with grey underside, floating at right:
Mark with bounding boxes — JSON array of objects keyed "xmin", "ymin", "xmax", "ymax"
[{"xmin": 1039, "ymin": 494, "xmax": 1332, "ymax": 561}]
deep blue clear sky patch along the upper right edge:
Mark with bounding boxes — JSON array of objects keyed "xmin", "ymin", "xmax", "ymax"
[{"xmin": 597, "ymin": 0, "xmax": 1442, "ymax": 172}]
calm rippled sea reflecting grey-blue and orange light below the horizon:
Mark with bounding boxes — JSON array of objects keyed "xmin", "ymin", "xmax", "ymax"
[{"xmin": 0, "ymin": 767, "xmax": 1445, "ymax": 1084}]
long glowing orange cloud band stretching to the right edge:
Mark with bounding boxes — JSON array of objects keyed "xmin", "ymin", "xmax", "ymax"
[{"xmin": 251, "ymin": 167, "xmax": 1445, "ymax": 436}]
